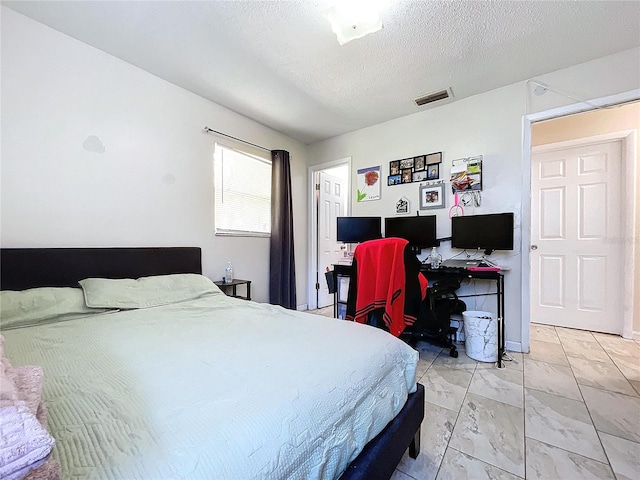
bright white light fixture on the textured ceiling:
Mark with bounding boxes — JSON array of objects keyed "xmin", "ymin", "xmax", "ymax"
[{"xmin": 325, "ymin": 0, "xmax": 382, "ymax": 45}]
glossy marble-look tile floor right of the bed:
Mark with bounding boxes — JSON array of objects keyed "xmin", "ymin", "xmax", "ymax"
[{"xmin": 312, "ymin": 312, "xmax": 640, "ymax": 480}]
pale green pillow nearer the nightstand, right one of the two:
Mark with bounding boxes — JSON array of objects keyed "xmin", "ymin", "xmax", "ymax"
[{"xmin": 80, "ymin": 273, "xmax": 222, "ymax": 309}]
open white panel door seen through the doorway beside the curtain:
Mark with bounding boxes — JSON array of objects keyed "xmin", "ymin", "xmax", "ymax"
[{"xmin": 318, "ymin": 172, "xmax": 346, "ymax": 308}]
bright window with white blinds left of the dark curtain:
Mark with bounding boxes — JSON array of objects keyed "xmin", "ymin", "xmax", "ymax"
[{"xmin": 213, "ymin": 142, "xmax": 272, "ymax": 238}]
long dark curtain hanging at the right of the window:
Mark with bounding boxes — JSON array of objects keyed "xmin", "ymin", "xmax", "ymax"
[{"xmin": 269, "ymin": 150, "xmax": 297, "ymax": 310}]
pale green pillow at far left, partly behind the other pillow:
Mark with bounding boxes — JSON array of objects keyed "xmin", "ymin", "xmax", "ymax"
[{"xmin": 0, "ymin": 287, "xmax": 106, "ymax": 329}]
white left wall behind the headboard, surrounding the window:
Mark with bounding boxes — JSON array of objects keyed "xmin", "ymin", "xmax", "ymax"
[{"xmin": 0, "ymin": 7, "xmax": 307, "ymax": 304}]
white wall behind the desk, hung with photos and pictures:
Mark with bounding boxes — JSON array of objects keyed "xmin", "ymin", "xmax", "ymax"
[{"xmin": 309, "ymin": 48, "xmax": 640, "ymax": 350}]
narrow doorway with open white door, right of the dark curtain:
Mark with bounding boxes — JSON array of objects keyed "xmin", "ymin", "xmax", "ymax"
[{"xmin": 308, "ymin": 157, "xmax": 351, "ymax": 310}]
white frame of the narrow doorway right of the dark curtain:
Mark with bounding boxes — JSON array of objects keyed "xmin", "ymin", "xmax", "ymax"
[{"xmin": 307, "ymin": 157, "xmax": 351, "ymax": 310}]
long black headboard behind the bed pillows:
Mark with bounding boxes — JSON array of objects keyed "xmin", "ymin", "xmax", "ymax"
[{"xmin": 0, "ymin": 247, "xmax": 202, "ymax": 290}]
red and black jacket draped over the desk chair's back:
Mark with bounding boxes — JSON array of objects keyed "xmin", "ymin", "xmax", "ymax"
[{"xmin": 346, "ymin": 238, "xmax": 427, "ymax": 337}]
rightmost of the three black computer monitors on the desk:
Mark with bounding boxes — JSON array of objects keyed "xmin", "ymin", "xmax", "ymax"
[{"xmin": 451, "ymin": 212, "xmax": 513, "ymax": 255}]
